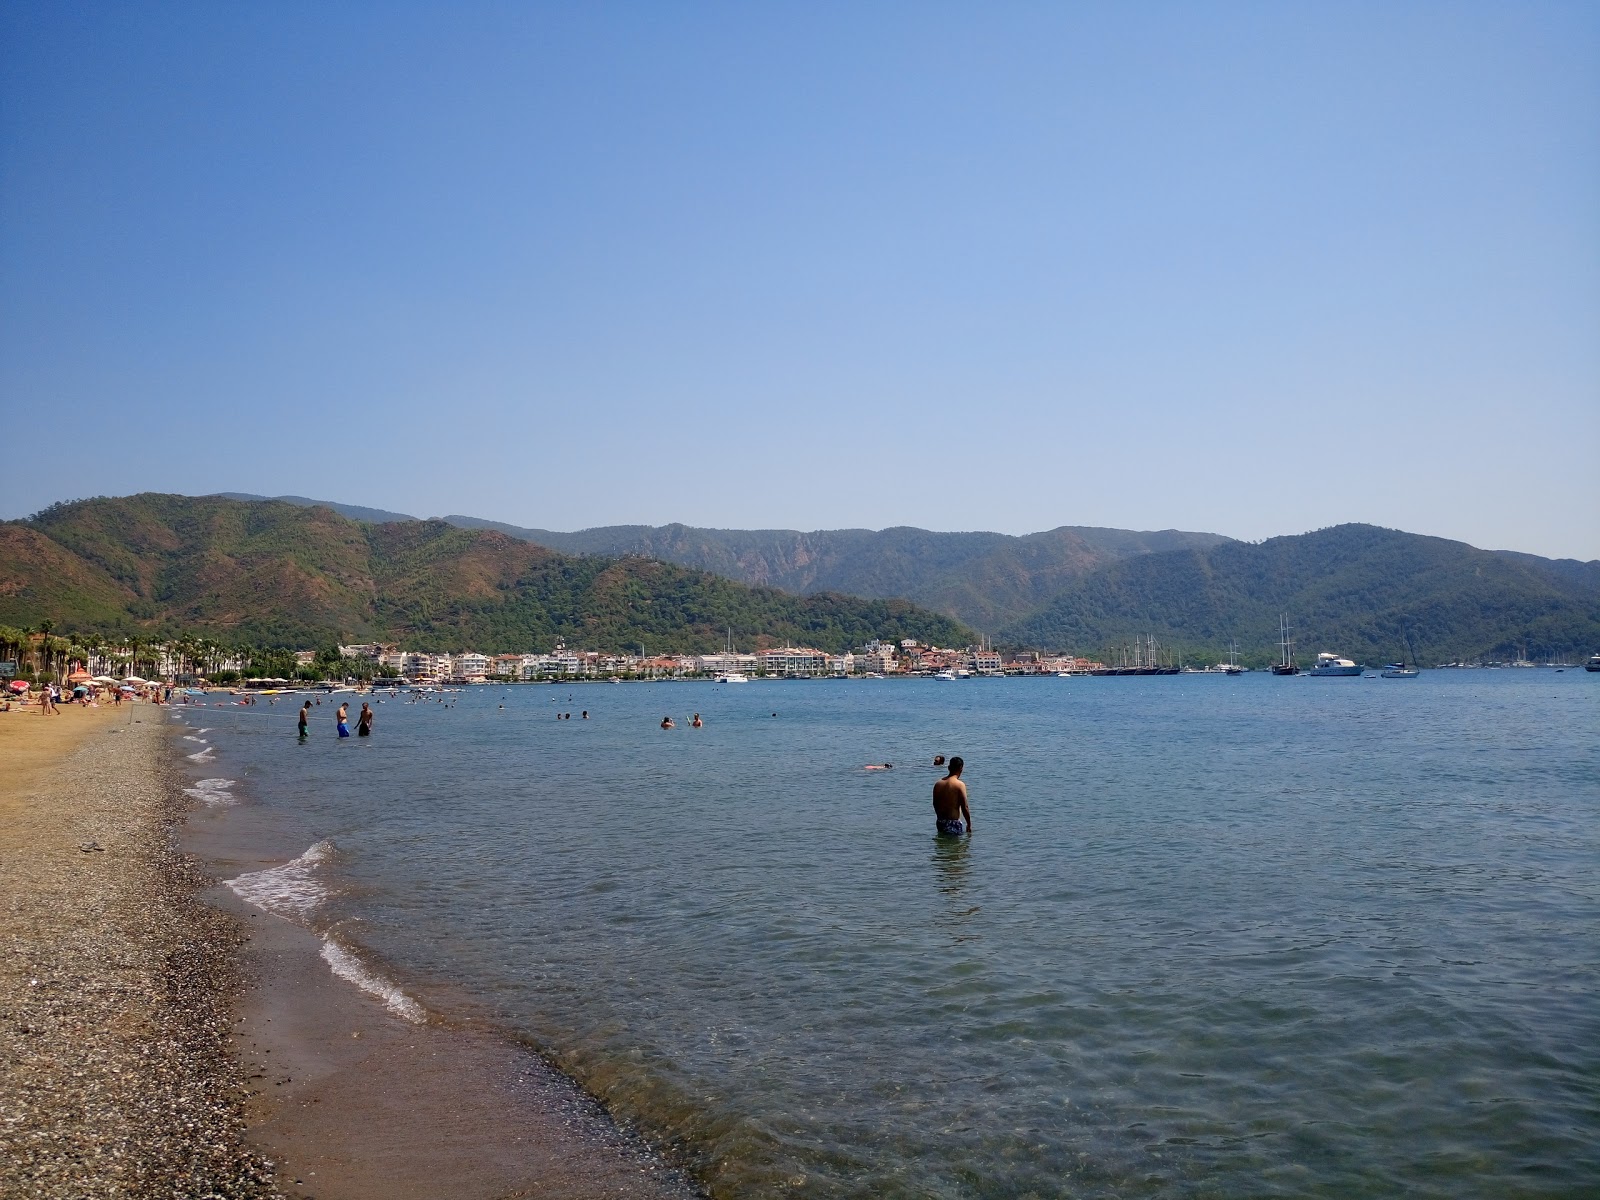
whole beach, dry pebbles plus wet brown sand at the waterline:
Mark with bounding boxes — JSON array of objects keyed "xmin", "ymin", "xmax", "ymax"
[{"xmin": 0, "ymin": 704, "xmax": 701, "ymax": 1200}]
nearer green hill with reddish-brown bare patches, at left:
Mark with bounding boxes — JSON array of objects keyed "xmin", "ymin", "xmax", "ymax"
[{"xmin": 0, "ymin": 493, "xmax": 974, "ymax": 653}]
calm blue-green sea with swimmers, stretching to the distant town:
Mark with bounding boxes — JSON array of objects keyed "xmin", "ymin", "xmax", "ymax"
[{"xmin": 186, "ymin": 670, "xmax": 1600, "ymax": 1197}]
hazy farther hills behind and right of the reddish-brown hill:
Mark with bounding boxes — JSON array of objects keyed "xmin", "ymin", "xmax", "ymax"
[{"xmin": 190, "ymin": 498, "xmax": 1600, "ymax": 661}]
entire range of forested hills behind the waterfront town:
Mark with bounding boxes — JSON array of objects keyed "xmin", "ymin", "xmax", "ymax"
[{"xmin": 9, "ymin": 494, "xmax": 1600, "ymax": 664}]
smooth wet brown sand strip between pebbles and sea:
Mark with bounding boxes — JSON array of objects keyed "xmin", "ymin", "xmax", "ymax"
[{"xmin": 178, "ymin": 710, "xmax": 706, "ymax": 1200}]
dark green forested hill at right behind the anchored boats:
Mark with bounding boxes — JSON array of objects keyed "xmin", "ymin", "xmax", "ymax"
[{"xmin": 1000, "ymin": 525, "xmax": 1600, "ymax": 662}]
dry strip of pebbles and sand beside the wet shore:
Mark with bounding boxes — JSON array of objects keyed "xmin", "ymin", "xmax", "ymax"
[{"xmin": 0, "ymin": 720, "xmax": 278, "ymax": 1200}]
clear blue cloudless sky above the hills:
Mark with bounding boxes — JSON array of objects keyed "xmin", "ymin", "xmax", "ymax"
[{"xmin": 0, "ymin": 0, "xmax": 1600, "ymax": 558}]
